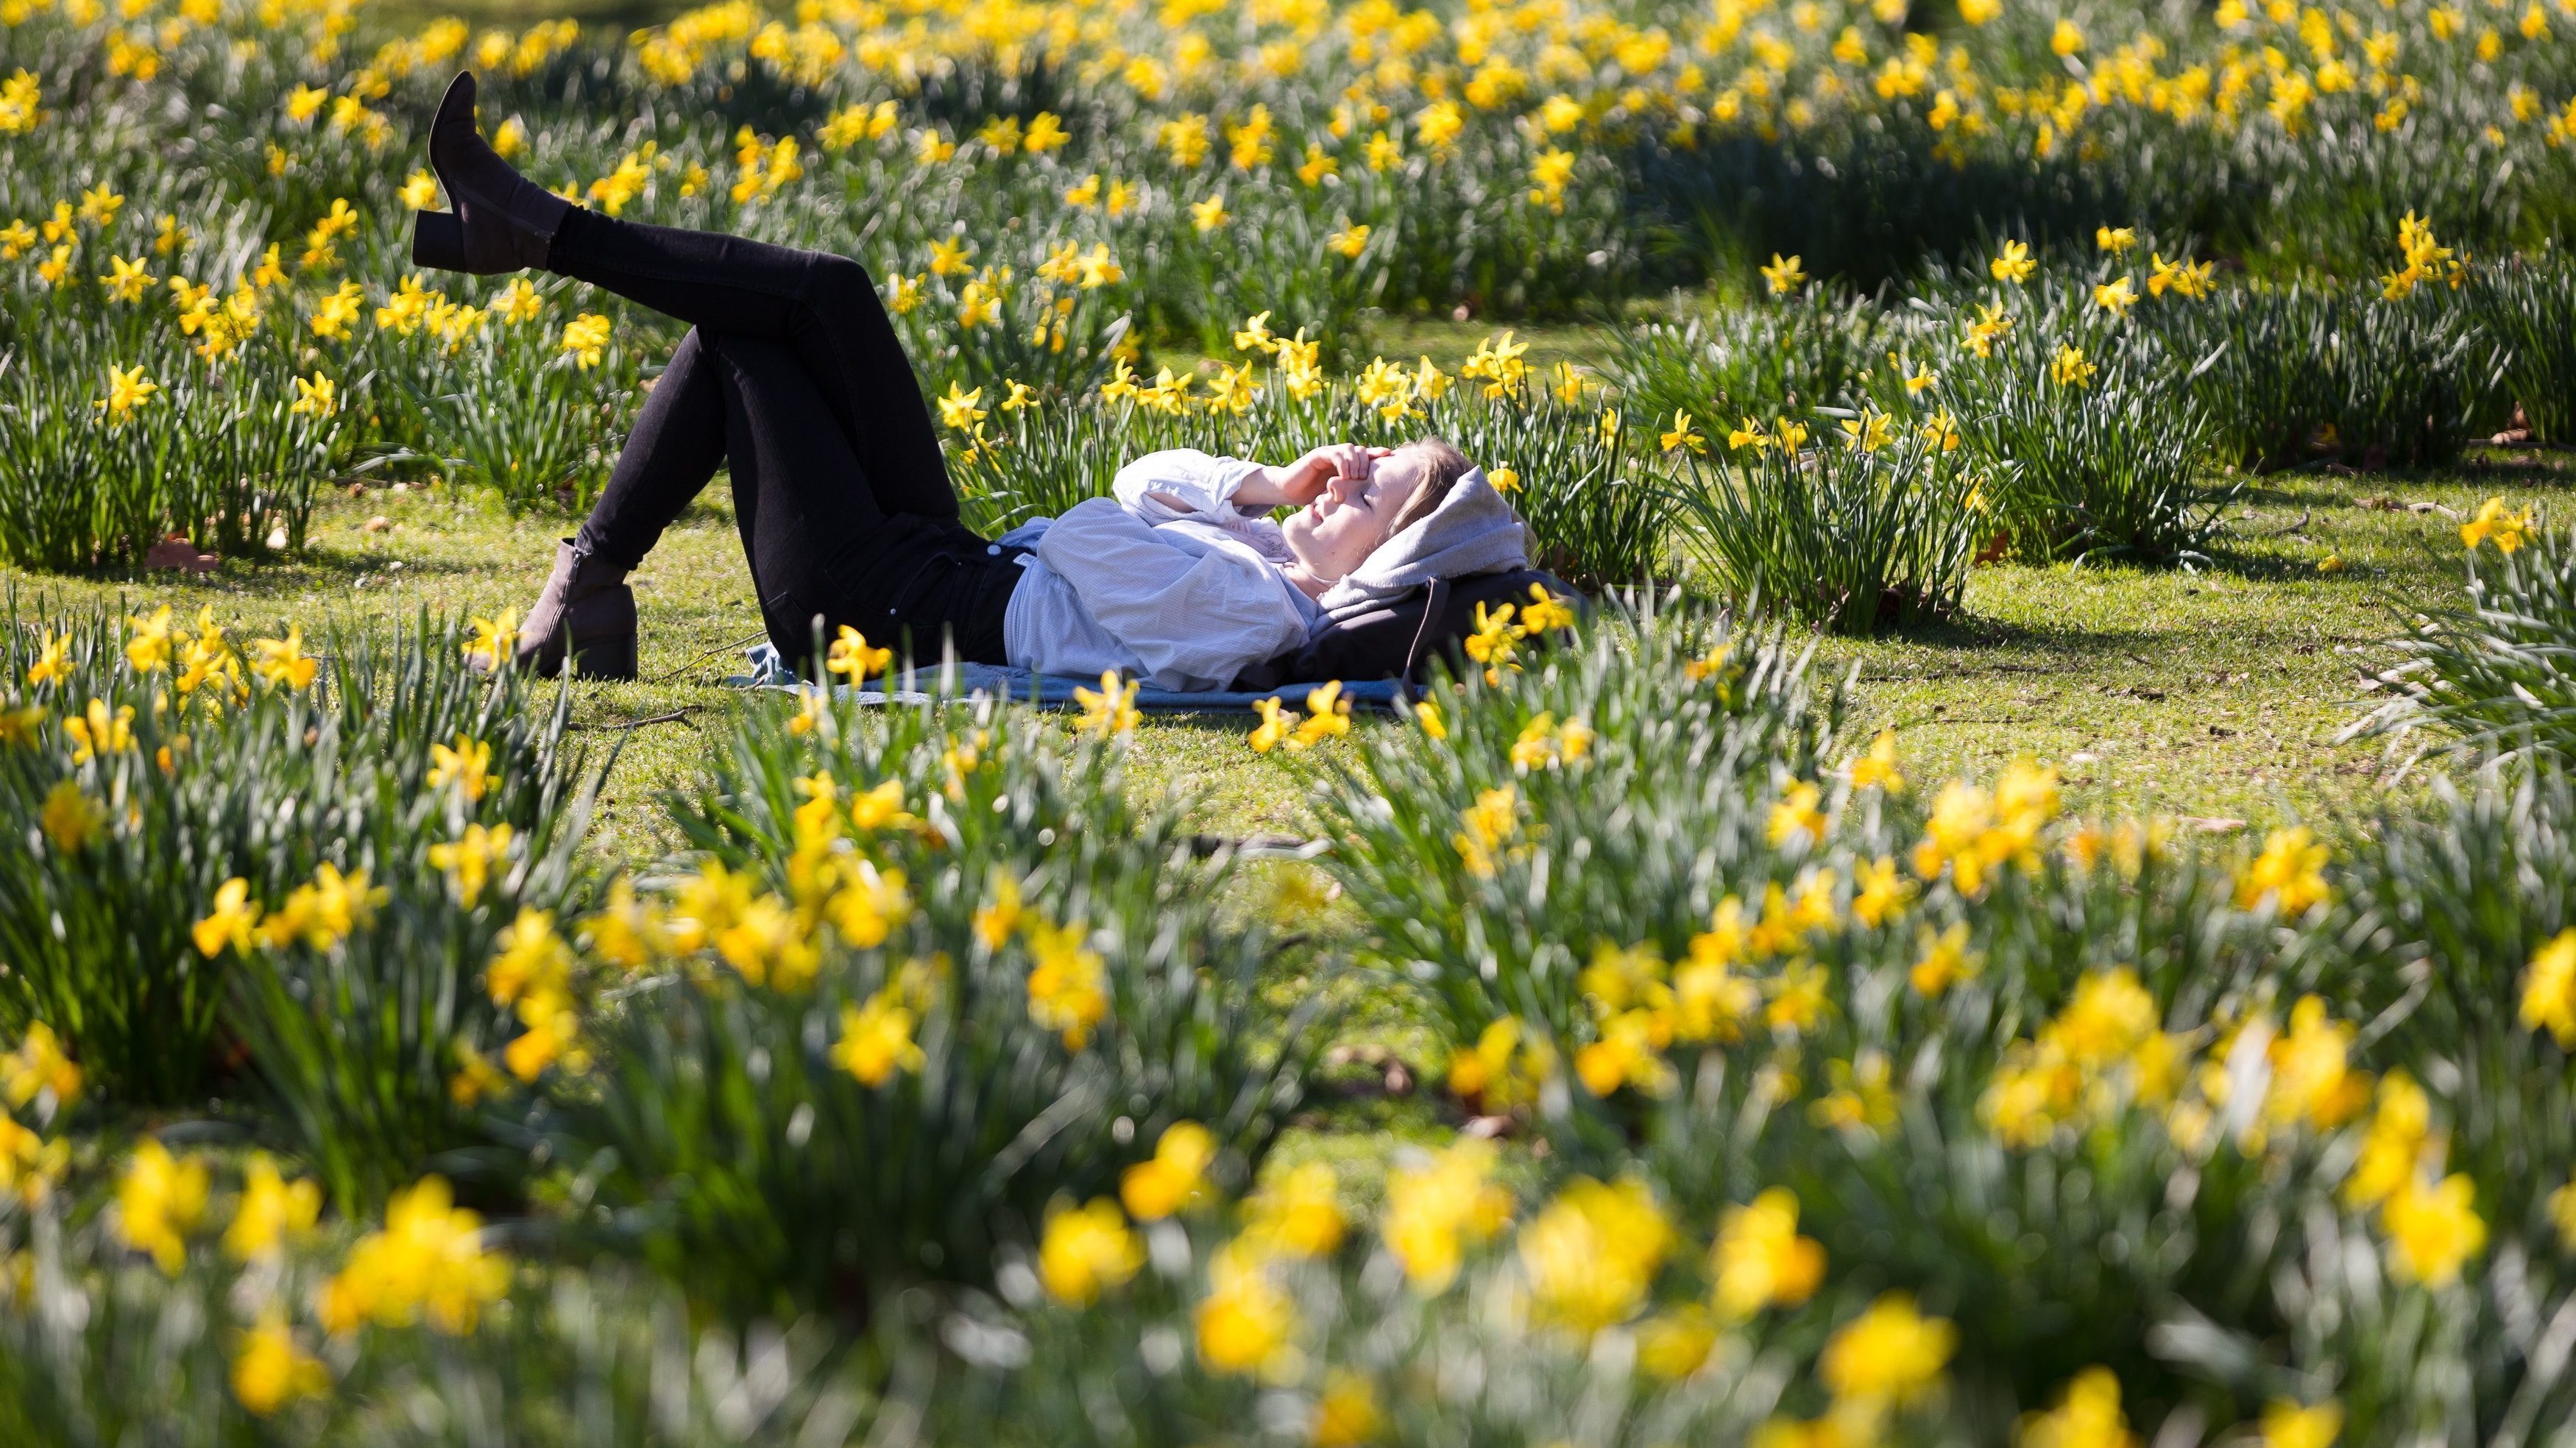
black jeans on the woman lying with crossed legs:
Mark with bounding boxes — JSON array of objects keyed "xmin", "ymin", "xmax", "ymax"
[{"xmin": 546, "ymin": 209, "xmax": 1020, "ymax": 672}]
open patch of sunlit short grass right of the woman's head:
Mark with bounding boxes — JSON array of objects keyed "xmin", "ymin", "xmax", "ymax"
[{"xmin": 1819, "ymin": 464, "xmax": 2535, "ymax": 830}]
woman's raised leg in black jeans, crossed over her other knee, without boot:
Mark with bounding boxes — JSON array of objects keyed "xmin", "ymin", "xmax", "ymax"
[{"xmin": 546, "ymin": 209, "xmax": 958, "ymax": 520}]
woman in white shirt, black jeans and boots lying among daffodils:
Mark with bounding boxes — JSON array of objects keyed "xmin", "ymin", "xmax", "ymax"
[{"xmin": 412, "ymin": 75, "xmax": 1528, "ymax": 690}]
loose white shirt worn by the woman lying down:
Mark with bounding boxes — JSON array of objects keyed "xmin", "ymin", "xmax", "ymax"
[{"xmin": 999, "ymin": 448, "xmax": 1324, "ymax": 690}]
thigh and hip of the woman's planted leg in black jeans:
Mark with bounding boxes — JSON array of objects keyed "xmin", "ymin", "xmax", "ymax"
[{"xmin": 701, "ymin": 333, "xmax": 1020, "ymax": 662}]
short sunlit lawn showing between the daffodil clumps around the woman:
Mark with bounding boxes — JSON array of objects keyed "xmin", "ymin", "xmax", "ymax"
[{"xmin": 0, "ymin": 324, "xmax": 2569, "ymax": 1203}]
